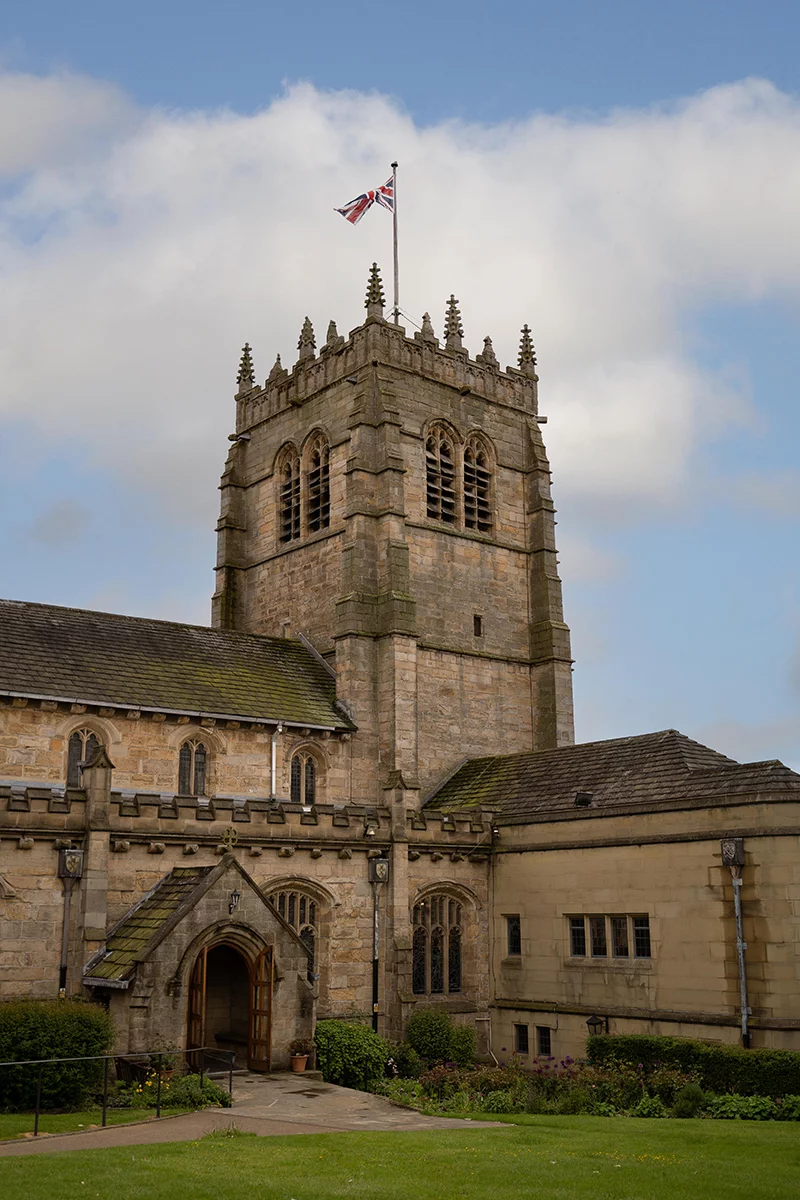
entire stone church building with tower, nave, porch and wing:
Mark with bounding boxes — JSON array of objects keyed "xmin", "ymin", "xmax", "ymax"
[{"xmin": 0, "ymin": 265, "xmax": 800, "ymax": 1070}]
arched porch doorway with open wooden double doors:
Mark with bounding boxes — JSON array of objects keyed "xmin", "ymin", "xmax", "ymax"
[{"xmin": 188, "ymin": 942, "xmax": 273, "ymax": 1070}]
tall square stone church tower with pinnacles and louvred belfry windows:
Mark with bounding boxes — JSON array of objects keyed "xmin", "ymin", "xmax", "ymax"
[{"xmin": 212, "ymin": 265, "xmax": 573, "ymax": 811}]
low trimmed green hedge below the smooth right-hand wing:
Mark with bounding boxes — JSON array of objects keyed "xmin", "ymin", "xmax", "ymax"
[{"xmin": 588, "ymin": 1033, "xmax": 800, "ymax": 1098}]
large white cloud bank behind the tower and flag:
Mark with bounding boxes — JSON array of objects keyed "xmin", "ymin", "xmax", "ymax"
[{"xmin": 0, "ymin": 76, "xmax": 800, "ymax": 524}]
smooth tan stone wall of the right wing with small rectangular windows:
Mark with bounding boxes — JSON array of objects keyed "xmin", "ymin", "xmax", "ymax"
[{"xmin": 493, "ymin": 803, "xmax": 800, "ymax": 1056}]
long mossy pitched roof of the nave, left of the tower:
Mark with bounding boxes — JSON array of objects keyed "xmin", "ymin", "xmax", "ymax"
[{"xmin": 0, "ymin": 600, "xmax": 353, "ymax": 730}]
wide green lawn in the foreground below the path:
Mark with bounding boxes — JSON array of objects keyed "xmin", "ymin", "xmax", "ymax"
[{"xmin": 0, "ymin": 1116, "xmax": 800, "ymax": 1200}]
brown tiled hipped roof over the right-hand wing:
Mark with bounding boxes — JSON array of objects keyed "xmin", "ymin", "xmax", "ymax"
[{"xmin": 426, "ymin": 730, "xmax": 800, "ymax": 821}]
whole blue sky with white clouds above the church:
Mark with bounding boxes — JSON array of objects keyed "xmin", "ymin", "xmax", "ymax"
[{"xmin": 0, "ymin": 0, "xmax": 800, "ymax": 767}]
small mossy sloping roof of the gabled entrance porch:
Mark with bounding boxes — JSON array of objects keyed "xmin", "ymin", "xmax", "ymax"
[{"xmin": 86, "ymin": 866, "xmax": 213, "ymax": 980}]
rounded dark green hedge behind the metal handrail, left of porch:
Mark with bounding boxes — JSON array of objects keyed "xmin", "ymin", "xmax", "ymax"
[{"xmin": 0, "ymin": 1000, "xmax": 114, "ymax": 1111}]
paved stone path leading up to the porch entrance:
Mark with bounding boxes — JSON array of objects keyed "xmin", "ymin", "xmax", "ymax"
[{"xmin": 0, "ymin": 1073, "xmax": 505, "ymax": 1157}]
